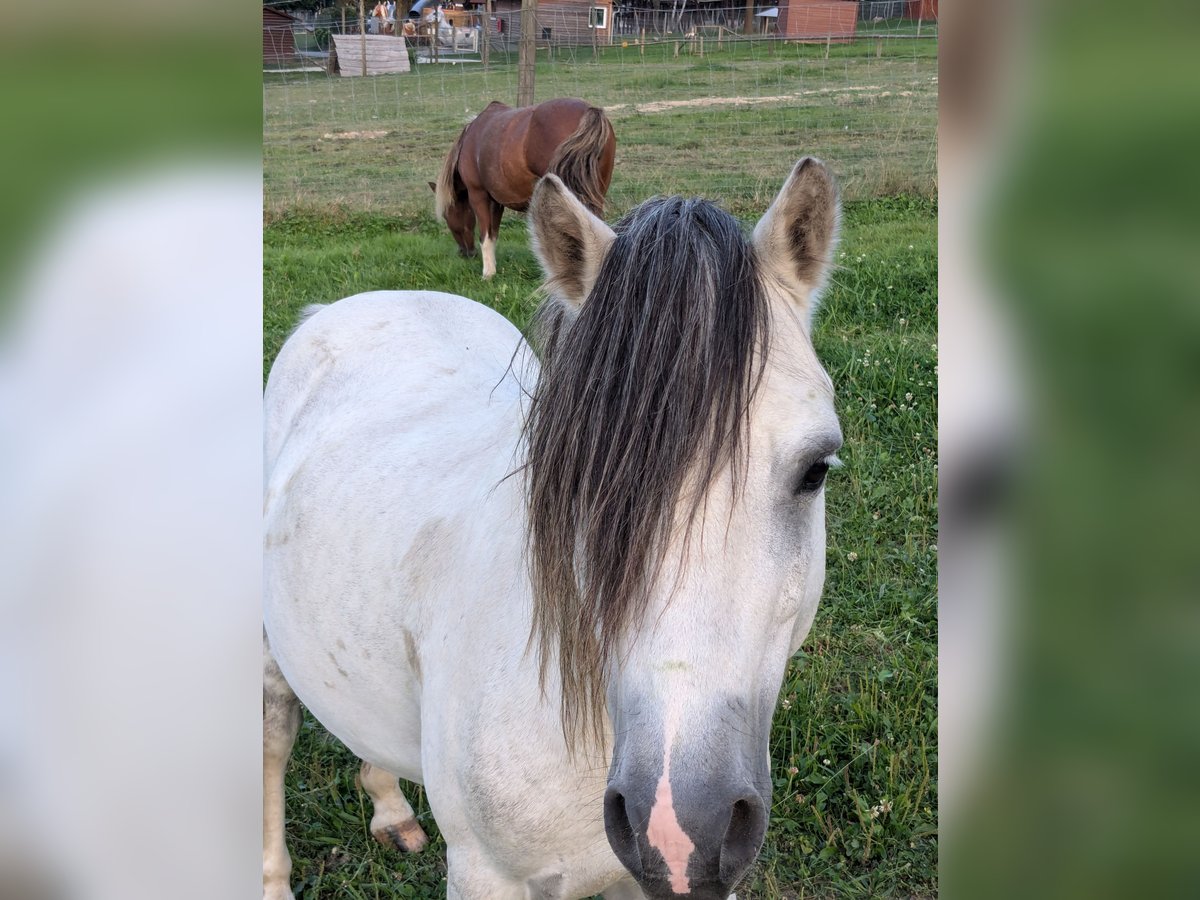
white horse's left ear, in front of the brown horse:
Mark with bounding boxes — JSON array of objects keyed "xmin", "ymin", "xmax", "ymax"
[{"xmin": 529, "ymin": 175, "xmax": 616, "ymax": 310}]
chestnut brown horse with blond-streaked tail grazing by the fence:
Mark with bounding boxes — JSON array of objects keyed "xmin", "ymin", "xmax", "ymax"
[{"xmin": 430, "ymin": 97, "xmax": 617, "ymax": 278}]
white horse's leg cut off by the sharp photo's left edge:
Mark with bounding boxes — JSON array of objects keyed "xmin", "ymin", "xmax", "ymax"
[{"xmin": 263, "ymin": 635, "xmax": 300, "ymax": 900}]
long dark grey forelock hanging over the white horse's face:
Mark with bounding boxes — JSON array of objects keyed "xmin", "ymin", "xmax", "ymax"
[{"xmin": 526, "ymin": 197, "xmax": 769, "ymax": 746}]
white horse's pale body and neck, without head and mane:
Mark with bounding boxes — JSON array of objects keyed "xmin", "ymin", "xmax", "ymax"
[{"xmin": 264, "ymin": 292, "xmax": 638, "ymax": 896}]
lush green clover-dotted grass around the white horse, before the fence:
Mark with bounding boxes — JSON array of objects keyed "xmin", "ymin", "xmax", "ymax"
[{"xmin": 264, "ymin": 194, "xmax": 937, "ymax": 900}]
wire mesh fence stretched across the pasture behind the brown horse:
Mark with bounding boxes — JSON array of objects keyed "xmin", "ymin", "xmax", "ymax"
[{"xmin": 263, "ymin": 0, "xmax": 937, "ymax": 220}]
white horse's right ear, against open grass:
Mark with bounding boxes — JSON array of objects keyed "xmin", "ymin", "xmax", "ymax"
[{"xmin": 752, "ymin": 156, "xmax": 841, "ymax": 324}]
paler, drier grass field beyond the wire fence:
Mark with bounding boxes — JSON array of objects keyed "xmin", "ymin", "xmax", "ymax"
[{"xmin": 263, "ymin": 40, "xmax": 937, "ymax": 217}]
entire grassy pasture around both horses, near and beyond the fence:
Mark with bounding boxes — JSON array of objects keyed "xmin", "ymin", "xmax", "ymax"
[{"xmin": 263, "ymin": 31, "xmax": 937, "ymax": 900}]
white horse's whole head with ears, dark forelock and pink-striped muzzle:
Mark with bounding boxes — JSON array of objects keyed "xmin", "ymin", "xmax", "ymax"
[{"xmin": 526, "ymin": 164, "xmax": 841, "ymax": 900}]
